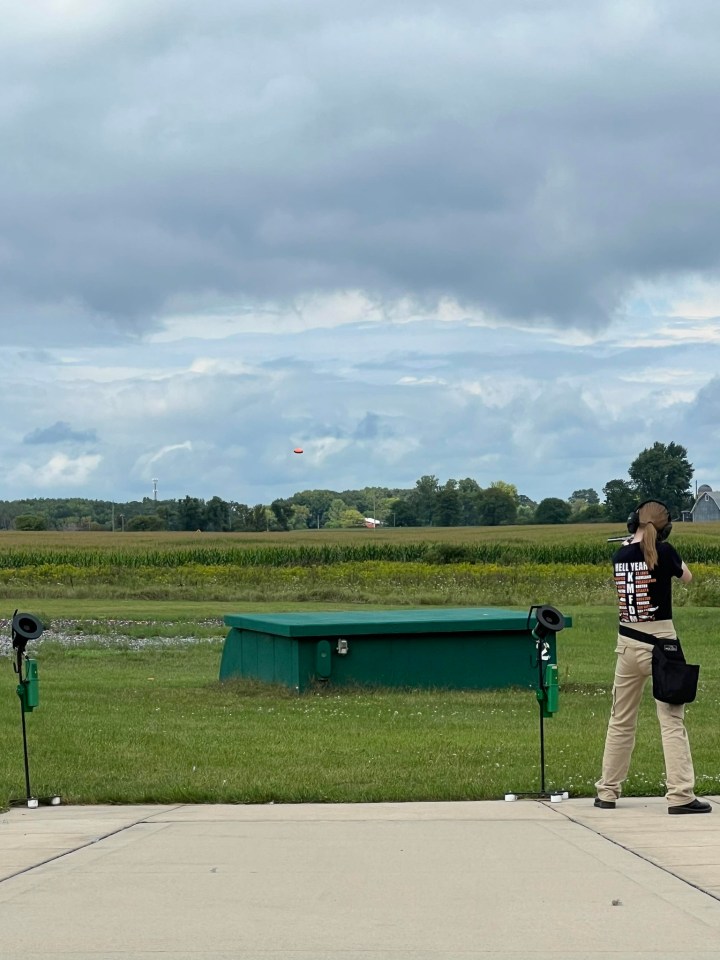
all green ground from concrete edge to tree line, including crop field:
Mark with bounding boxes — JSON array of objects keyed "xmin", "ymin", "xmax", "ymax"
[{"xmin": 0, "ymin": 524, "xmax": 720, "ymax": 806}]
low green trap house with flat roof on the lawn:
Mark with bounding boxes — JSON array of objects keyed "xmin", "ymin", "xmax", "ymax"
[{"xmin": 220, "ymin": 607, "xmax": 571, "ymax": 693}]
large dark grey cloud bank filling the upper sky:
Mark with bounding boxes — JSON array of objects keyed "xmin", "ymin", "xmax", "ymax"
[{"xmin": 0, "ymin": 0, "xmax": 720, "ymax": 343}]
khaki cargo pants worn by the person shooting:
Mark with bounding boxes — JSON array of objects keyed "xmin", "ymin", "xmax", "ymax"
[{"xmin": 595, "ymin": 620, "xmax": 695, "ymax": 807}]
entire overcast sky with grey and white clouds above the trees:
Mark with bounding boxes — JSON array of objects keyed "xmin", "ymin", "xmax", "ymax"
[{"xmin": 0, "ymin": 0, "xmax": 720, "ymax": 504}]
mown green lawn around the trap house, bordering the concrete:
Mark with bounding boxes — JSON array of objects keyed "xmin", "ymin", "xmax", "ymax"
[{"xmin": 0, "ymin": 598, "xmax": 720, "ymax": 806}]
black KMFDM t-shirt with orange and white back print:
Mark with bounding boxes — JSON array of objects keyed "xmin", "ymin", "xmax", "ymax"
[{"xmin": 613, "ymin": 542, "xmax": 682, "ymax": 623}]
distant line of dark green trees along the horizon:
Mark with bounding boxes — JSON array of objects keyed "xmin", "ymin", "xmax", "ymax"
[{"xmin": 0, "ymin": 442, "xmax": 693, "ymax": 533}]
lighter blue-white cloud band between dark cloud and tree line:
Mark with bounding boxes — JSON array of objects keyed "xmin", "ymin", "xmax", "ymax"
[{"xmin": 0, "ymin": 318, "xmax": 720, "ymax": 503}]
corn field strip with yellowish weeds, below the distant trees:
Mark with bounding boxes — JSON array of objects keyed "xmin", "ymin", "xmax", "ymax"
[{"xmin": 0, "ymin": 524, "xmax": 720, "ymax": 606}]
